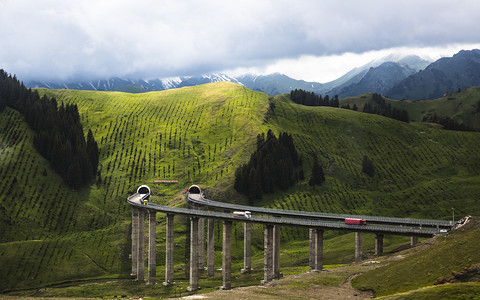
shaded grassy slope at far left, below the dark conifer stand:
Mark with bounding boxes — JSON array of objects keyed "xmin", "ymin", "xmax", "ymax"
[{"xmin": 0, "ymin": 108, "xmax": 128, "ymax": 290}]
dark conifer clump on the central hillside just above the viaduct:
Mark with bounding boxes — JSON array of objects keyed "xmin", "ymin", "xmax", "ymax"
[{"xmin": 234, "ymin": 130, "xmax": 304, "ymax": 204}]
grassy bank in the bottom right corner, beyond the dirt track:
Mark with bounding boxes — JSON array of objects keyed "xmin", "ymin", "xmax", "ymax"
[{"xmin": 353, "ymin": 218, "xmax": 480, "ymax": 296}]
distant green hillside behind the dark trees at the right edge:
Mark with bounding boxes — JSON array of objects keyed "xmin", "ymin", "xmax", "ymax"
[{"xmin": 340, "ymin": 87, "xmax": 480, "ymax": 129}]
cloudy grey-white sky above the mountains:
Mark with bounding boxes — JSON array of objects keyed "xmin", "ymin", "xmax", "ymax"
[{"xmin": 0, "ymin": 0, "xmax": 480, "ymax": 82}]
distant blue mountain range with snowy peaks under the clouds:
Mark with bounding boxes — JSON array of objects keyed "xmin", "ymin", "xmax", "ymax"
[{"xmin": 25, "ymin": 50, "xmax": 480, "ymax": 100}]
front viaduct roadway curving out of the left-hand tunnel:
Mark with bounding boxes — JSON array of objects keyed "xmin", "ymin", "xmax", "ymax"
[{"xmin": 127, "ymin": 193, "xmax": 446, "ymax": 237}]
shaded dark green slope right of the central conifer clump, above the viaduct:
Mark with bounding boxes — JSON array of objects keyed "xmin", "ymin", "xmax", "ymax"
[{"xmin": 266, "ymin": 97, "xmax": 480, "ymax": 218}]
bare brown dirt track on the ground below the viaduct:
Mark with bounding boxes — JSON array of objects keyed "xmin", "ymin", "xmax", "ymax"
[{"xmin": 178, "ymin": 264, "xmax": 376, "ymax": 300}]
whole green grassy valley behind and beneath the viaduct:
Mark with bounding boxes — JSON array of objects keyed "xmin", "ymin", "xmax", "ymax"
[{"xmin": 0, "ymin": 82, "xmax": 480, "ymax": 297}]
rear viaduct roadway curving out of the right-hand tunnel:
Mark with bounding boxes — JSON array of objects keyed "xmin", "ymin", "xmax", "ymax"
[{"xmin": 187, "ymin": 193, "xmax": 454, "ymax": 229}]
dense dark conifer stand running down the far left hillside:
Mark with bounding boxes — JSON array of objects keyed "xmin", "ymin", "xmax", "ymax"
[{"xmin": 0, "ymin": 70, "xmax": 100, "ymax": 189}]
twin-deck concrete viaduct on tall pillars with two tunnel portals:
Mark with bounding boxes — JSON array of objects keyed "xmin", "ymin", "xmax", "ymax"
[{"xmin": 127, "ymin": 185, "xmax": 454, "ymax": 291}]
